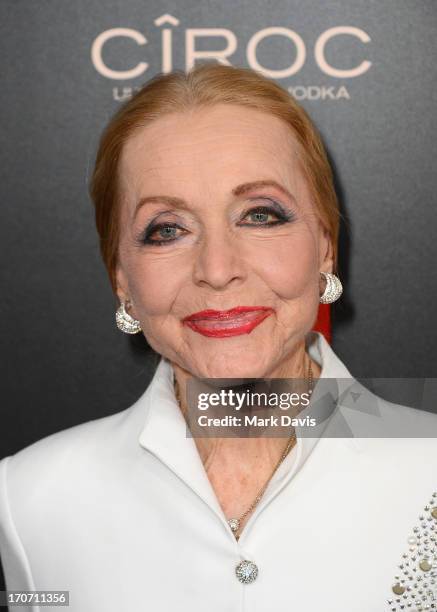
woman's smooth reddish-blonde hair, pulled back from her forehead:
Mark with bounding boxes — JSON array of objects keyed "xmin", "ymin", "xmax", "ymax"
[{"xmin": 90, "ymin": 63, "xmax": 340, "ymax": 293}]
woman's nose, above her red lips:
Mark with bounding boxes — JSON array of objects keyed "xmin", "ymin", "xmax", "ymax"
[{"xmin": 193, "ymin": 229, "xmax": 246, "ymax": 290}]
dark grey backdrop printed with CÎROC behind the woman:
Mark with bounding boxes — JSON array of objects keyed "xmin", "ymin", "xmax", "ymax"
[{"xmin": 0, "ymin": 0, "xmax": 437, "ymax": 596}]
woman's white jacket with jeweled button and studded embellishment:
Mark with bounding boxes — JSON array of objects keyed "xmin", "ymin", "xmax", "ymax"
[{"xmin": 0, "ymin": 332, "xmax": 437, "ymax": 612}]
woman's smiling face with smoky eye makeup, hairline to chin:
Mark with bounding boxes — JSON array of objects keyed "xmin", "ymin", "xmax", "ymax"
[{"xmin": 117, "ymin": 104, "xmax": 332, "ymax": 378}]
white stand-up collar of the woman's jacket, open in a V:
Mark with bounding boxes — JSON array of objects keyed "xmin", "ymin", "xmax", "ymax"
[{"xmin": 137, "ymin": 332, "xmax": 361, "ymax": 541}]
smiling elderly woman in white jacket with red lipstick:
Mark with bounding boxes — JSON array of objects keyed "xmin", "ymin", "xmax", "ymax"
[{"xmin": 0, "ymin": 64, "xmax": 437, "ymax": 612}]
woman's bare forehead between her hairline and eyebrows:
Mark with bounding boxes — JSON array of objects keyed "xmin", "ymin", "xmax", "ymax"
[{"xmin": 120, "ymin": 105, "xmax": 304, "ymax": 198}]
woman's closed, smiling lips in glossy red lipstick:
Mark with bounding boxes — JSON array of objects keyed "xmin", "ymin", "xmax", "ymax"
[{"xmin": 182, "ymin": 306, "xmax": 274, "ymax": 338}]
